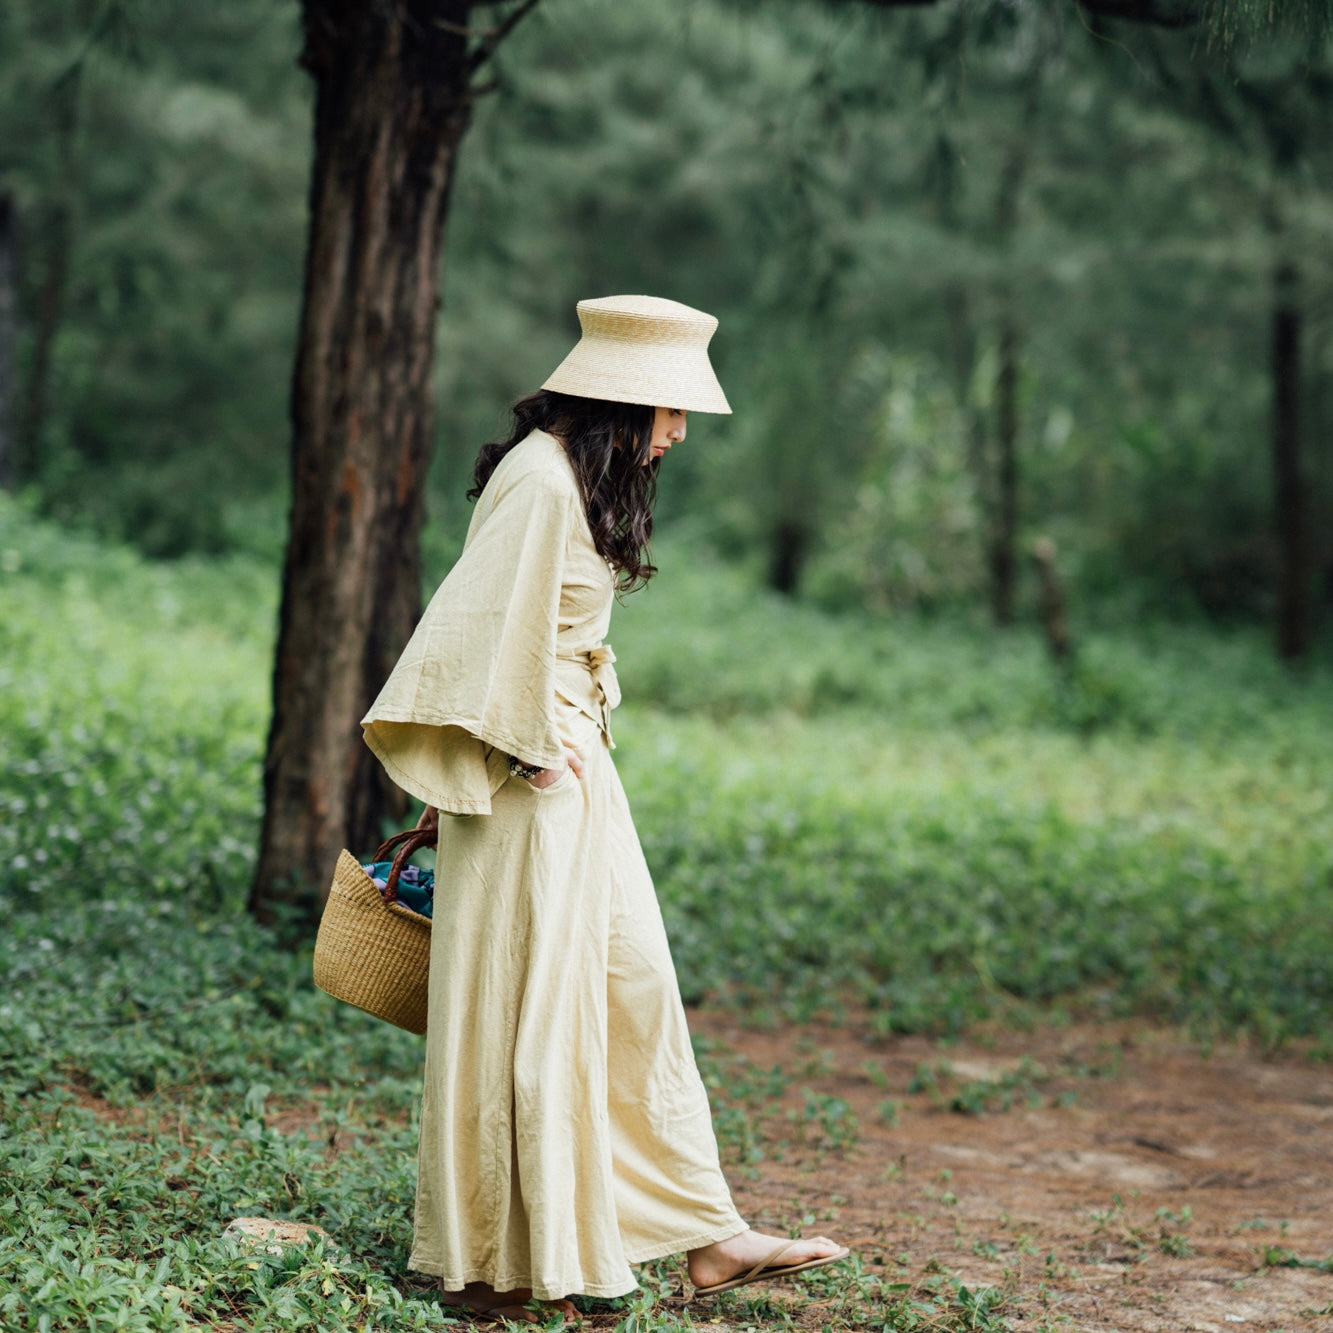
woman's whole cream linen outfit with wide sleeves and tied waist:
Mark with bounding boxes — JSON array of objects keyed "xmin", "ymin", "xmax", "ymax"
[{"xmin": 363, "ymin": 432, "xmax": 745, "ymax": 1300}]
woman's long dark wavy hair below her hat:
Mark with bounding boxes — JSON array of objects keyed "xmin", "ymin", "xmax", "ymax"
[{"xmin": 468, "ymin": 389, "xmax": 657, "ymax": 592}]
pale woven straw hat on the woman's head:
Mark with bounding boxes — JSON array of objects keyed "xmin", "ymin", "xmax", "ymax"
[{"xmin": 543, "ymin": 296, "xmax": 732, "ymax": 413}]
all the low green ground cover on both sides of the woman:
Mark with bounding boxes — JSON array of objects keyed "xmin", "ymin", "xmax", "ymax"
[{"xmin": 0, "ymin": 503, "xmax": 1333, "ymax": 1329}]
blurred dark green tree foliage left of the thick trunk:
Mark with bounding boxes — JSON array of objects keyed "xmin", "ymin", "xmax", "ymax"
[{"xmin": 0, "ymin": 0, "xmax": 309, "ymax": 556}]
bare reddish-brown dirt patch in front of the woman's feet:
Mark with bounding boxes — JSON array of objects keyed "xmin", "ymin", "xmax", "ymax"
[{"xmin": 690, "ymin": 1009, "xmax": 1333, "ymax": 1333}]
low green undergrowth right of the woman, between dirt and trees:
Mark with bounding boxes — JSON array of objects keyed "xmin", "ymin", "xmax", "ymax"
[{"xmin": 615, "ymin": 560, "xmax": 1333, "ymax": 1040}]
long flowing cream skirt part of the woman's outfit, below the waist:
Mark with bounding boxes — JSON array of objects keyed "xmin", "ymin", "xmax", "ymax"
[{"xmin": 409, "ymin": 709, "xmax": 745, "ymax": 1300}]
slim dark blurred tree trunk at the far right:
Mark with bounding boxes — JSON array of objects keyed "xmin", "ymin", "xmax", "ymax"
[{"xmin": 1272, "ymin": 260, "xmax": 1313, "ymax": 661}]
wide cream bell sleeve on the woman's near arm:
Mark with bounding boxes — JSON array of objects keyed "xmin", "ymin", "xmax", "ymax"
[{"xmin": 361, "ymin": 457, "xmax": 585, "ymax": 814}]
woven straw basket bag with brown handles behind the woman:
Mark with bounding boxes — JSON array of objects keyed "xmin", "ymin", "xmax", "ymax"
[{"xmin": 315, "ymin": 829, "xmax": 436, "ymax": 1034}]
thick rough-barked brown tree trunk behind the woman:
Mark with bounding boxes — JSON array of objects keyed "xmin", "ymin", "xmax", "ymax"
[{"xmin": 249, "ymin": 0, "xmax": 475, "ymax": 921}]
